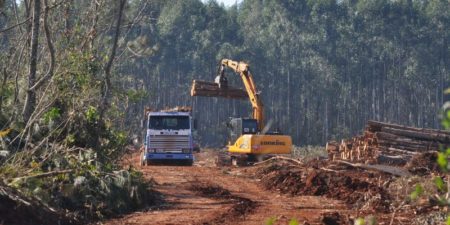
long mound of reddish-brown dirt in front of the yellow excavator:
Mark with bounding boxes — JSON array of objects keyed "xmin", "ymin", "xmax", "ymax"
[{"xmin": 257, "ymin": 163, "xmax": 390, "ymax": 212}]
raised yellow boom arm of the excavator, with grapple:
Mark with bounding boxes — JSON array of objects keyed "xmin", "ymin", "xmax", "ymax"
[{"xmin": 215, "ymin": 59, "xmax": 264, "ymax": 131}]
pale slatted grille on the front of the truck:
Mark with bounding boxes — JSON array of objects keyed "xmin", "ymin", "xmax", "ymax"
[{"xmin": 149, "ymin": 135, "xmax": 191, "ymax": 151}]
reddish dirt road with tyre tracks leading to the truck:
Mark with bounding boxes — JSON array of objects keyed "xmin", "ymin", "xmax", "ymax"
[{"xmin": 106, "ymin": 152, "xmax": 354, "ymax": 225}]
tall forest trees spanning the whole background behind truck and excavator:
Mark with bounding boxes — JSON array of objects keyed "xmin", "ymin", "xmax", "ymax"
[{"xmin": 0, "ymin": 0, "xmax": 450, "ymax": 147}]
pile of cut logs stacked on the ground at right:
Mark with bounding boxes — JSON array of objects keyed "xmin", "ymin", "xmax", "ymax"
[{"xmin": 326, "ymin": 121, "xmax": 450, "ymax": 165}]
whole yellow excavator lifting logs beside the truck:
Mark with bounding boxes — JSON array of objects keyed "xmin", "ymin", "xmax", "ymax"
[{"xmin": 191, "ymin": 59, "xmax": 292, "ymax": 163}]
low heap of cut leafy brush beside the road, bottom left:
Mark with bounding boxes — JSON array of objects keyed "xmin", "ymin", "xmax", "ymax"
[{"xmin": 0, "ymin": 146, "xmax": 149, "ymax": 219}]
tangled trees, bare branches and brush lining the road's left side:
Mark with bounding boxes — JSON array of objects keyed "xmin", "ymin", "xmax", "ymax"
[{"xmin": 0, "ymin": 0, "xmax": 153, "ymax": 224}]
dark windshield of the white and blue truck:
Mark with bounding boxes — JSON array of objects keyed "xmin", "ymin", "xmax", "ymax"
[{"xmin": 148, "ymin": 116, "xmax": 189, "ymax": 130}]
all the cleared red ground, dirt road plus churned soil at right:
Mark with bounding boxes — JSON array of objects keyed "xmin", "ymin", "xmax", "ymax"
[{"xmin": 105, "ymin": 151, "xmax": 428, "ymax": 224}]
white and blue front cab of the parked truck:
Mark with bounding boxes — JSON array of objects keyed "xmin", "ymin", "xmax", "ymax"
[{"xmin": 141, "ymin": 111, "xmax": 194, "ymax": 165}]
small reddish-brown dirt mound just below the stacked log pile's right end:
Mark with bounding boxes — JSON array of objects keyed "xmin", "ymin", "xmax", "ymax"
[{"xmin": 405, "ymin": 152, "xmax": 440, "ymax": 175}]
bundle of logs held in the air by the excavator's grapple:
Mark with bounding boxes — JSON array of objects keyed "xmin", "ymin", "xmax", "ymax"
[{"xmin": 191, "ymin": 80, "xmax": 248, "ymax": 99}]
